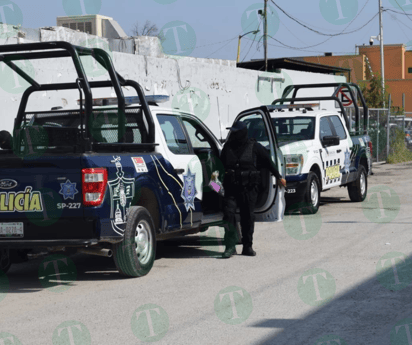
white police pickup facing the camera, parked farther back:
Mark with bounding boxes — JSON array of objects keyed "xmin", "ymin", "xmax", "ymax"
[{"xmin": 268, "ymin": 83, "xmax": 372, "ymax": 213}]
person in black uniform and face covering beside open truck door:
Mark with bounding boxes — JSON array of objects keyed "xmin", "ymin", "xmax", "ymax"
[{"xmin": 221, "ymin": 122, "xmax": 286, "ymax": 258}]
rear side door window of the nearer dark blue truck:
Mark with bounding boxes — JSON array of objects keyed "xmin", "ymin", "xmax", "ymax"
[{"xmin": 157, "ymin": 115, "xmax": 190, "ymax": 155}]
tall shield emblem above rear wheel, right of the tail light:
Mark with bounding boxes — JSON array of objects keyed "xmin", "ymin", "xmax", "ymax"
[{"xmin": 108, "ymin": 157, "xmax": 134, "ymax": 235}]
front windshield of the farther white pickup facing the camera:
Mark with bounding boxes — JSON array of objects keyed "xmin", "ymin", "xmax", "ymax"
[{"xmin": 272, "ymin": 116, "xmax": 315, "ymax": 145}]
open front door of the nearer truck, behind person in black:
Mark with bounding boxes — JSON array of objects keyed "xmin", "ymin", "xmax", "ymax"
[{"xmin": 227, "ymin": 106, "xmax": 286, "ymax": 222}]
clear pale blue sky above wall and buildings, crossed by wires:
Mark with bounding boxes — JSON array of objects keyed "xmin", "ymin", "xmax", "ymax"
[{"xmin": 0, "ymin": 0, "xmax": 412, "ymax": 61}]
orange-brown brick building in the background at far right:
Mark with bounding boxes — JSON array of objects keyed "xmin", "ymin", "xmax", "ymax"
[{"xmin": 294, "ymin": 44, "xmax": 412, "ymax": 116}]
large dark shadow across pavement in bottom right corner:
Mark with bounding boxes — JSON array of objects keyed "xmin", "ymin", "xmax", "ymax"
[{"xmin": 252, "ymin": 253, "xmax": 412, "ymax": 345}]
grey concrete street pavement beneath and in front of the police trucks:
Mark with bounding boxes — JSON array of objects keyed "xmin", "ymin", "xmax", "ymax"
[{"xmin": 0, "ymin": 164, "xmax": 412, "ymax": 345}]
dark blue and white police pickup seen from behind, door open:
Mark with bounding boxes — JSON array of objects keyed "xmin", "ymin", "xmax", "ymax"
[{"xmin": 0, "ymin": 42, "xmax": 285, "ymax": 277}]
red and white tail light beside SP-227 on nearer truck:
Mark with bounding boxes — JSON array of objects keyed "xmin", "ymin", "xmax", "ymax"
[{"xmin": 82, "ymin": 168, "xmax": 107, "ymax": 206}]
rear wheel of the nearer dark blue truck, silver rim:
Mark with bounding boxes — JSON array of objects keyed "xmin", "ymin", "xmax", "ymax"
[{"xmin": 113, "ymin": 206, "xmax": 156, "ymax": 277}]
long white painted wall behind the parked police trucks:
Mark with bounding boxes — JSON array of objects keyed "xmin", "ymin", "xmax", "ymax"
[{"xmin": 0, "ymin": 30, "xmax": 345, "ymax": 138}]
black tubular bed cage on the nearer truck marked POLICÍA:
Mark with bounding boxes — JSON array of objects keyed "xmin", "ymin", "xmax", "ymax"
[{"xmin": 0, "ymin": 41, "xmax": 155, "ymax": 151}]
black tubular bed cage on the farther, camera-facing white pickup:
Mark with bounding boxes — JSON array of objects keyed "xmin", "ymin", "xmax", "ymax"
[{"xmin": 269, "ymin": 83, "xmax": 369, "ymax": 134}]
